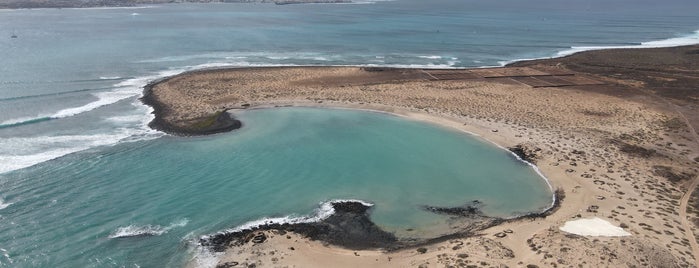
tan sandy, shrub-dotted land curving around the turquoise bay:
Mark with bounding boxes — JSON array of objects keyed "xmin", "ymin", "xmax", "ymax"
[{"xmin": 144, "ymin": 46, "xmax": 699, "ymax": 267}]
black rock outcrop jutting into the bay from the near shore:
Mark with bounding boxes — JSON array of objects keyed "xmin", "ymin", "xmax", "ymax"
[{"xmin": 199, "ymin": 201, "xmax": 398, "ymax": 252}]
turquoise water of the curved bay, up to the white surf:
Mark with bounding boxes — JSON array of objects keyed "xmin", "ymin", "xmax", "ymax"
[{"xmin": 0, "ymin": 108, "xmax": 551, "ymax": 267}]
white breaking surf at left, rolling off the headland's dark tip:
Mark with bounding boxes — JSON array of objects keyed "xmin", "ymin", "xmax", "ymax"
[{"xmin": 0, "ymin": 63, "xmax": 241, "ymax": 174}]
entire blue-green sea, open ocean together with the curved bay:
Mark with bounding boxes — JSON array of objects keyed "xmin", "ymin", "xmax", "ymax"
[{"xmin": 0, "ymin": 0, "xmax": 699, "ymax": 267}]
